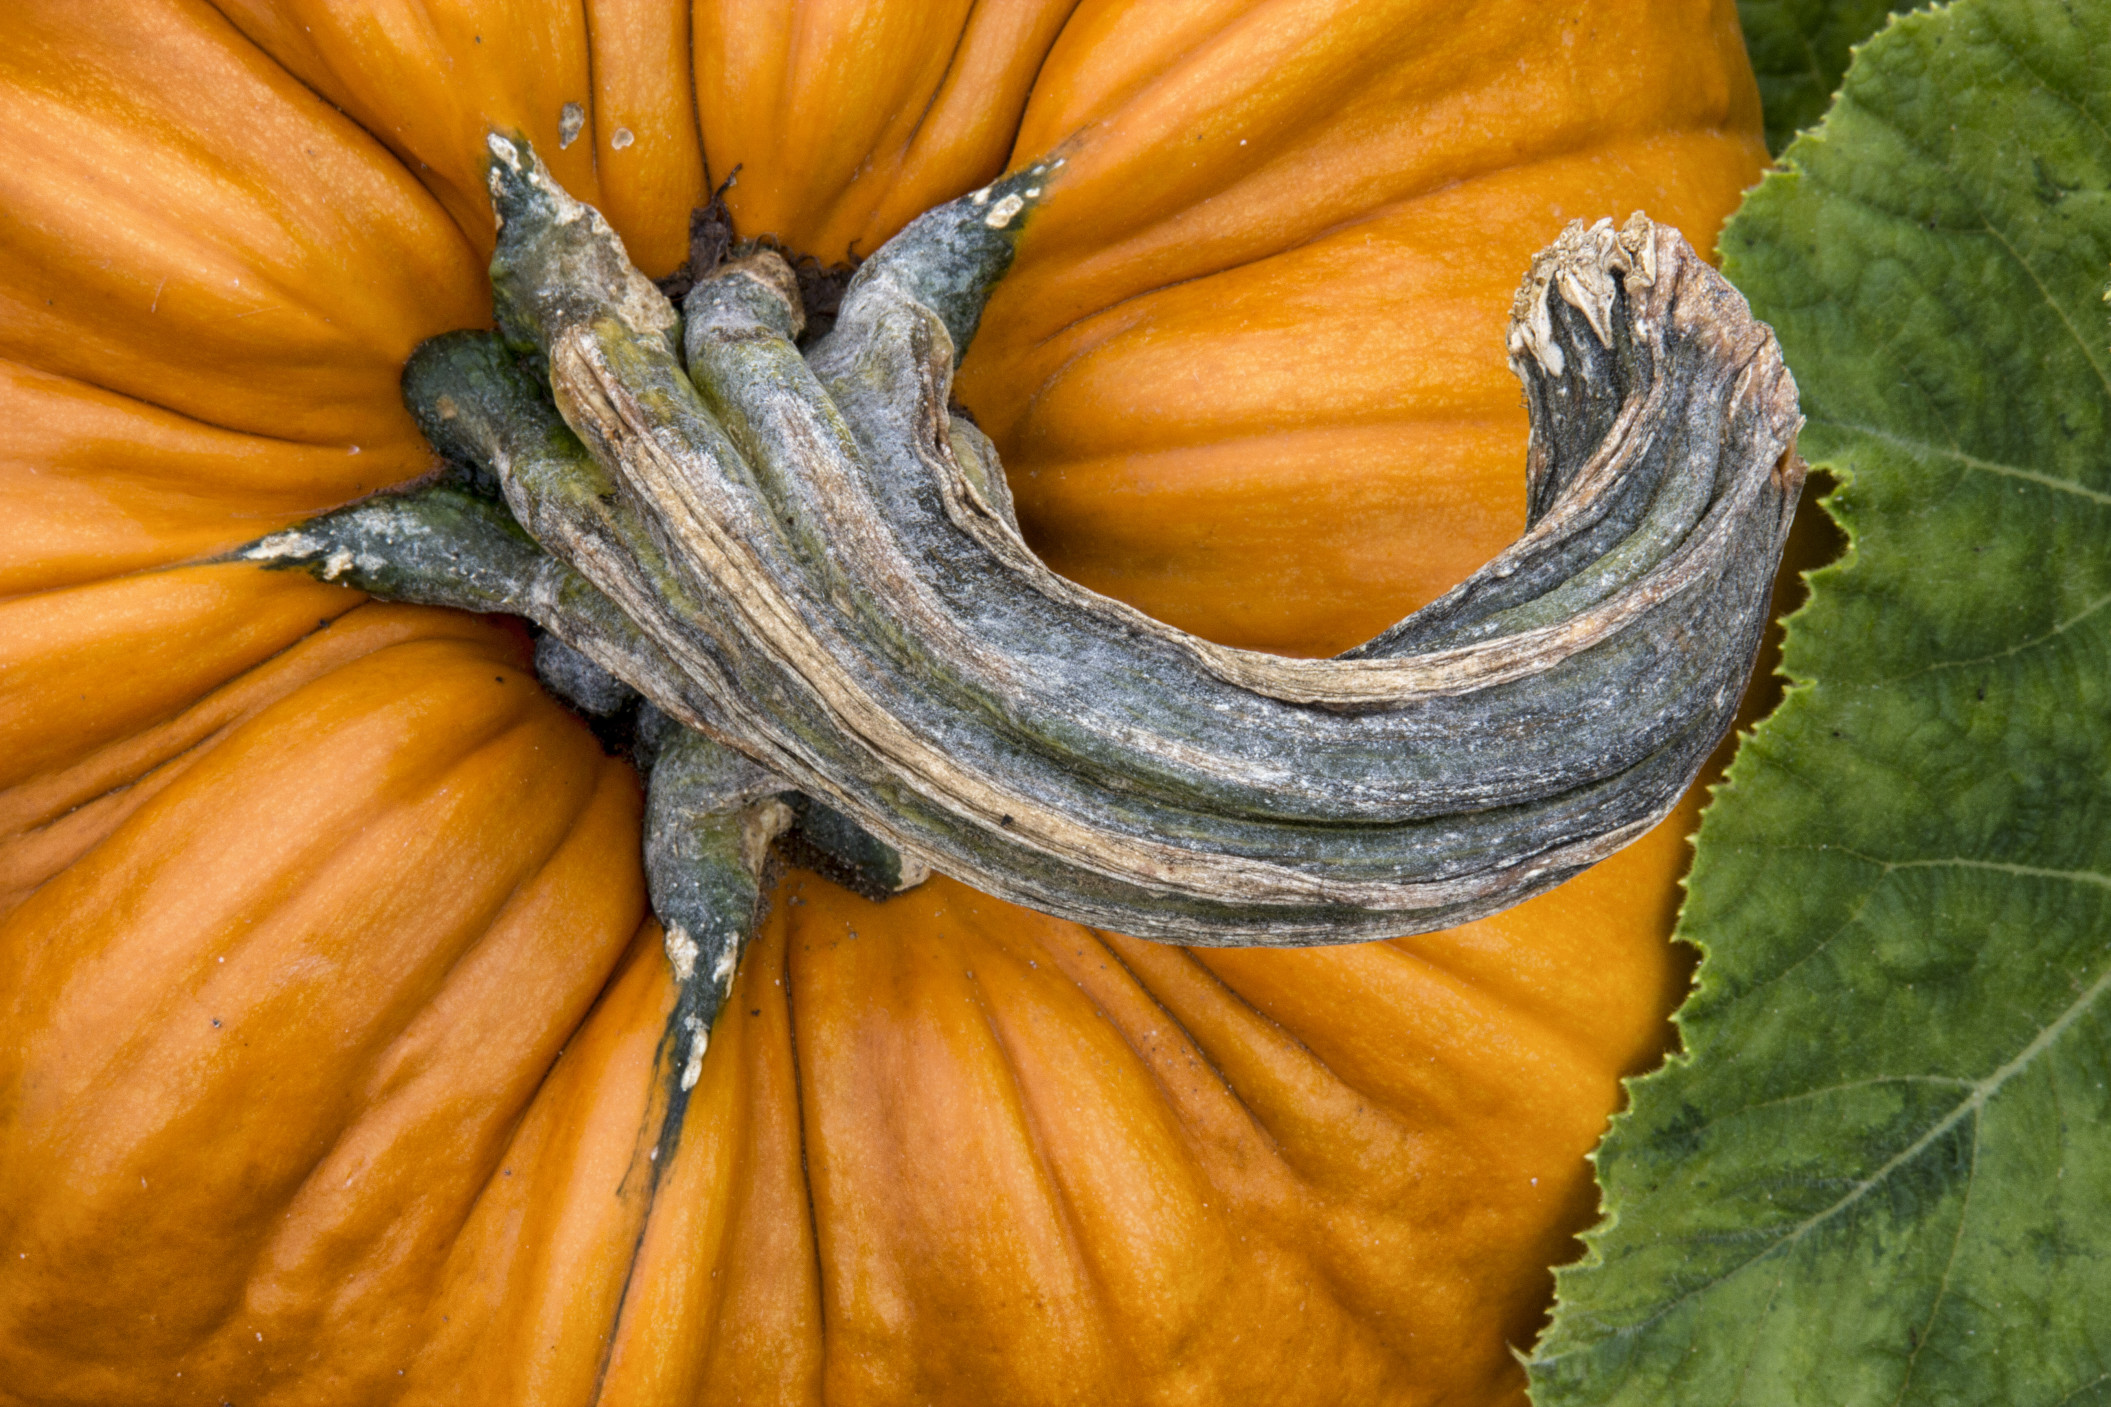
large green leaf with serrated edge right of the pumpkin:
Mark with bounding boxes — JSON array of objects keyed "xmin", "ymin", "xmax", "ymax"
[{"xmin": 1530, "ymin": 0, "xmax": 2111, "ymax": 1407}]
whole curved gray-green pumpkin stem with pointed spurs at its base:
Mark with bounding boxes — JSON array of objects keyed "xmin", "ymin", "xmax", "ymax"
[{"xmin": 241, "ymin": 137, "xmax": 1803, "ymax": 991}]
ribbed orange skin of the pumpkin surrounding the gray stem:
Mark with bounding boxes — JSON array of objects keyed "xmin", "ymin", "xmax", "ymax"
[{"xmin": 0, "ymin": 0, "xmax": 1763, "ymax": 1407}]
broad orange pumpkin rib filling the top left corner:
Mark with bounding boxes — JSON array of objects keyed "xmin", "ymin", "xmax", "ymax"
[{"xmin": 0, "ymin": 0, "xmax": 483, "ymax": 454}]
